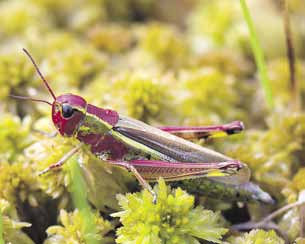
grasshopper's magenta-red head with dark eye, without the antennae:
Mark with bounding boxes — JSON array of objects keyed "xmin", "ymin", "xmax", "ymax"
[{"xmin": 52, "ymin": 94, "xmax": 87, "ymax": 136}]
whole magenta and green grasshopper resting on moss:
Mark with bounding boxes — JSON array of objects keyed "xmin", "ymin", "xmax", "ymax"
[{"xmin": 12, "ymin": 49, "xmax": 272, "ymax": 203}]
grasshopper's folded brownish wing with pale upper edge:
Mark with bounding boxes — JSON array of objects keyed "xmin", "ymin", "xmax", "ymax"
[{"xmin": 113, "ymin": 115, "xmax": 250, "ymax": 185}]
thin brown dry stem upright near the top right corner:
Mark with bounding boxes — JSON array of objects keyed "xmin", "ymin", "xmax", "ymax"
[{"xmin": 283, "ymin": 0, "xmax": 301, "ymax": 110}]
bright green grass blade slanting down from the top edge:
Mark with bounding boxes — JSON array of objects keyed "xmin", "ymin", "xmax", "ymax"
[{"xmin": 240, "ymin": 0, "xmax": 274, "ymax": 109}]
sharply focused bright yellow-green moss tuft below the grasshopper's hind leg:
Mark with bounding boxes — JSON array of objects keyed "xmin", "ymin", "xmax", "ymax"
[{"xmin": 112, "ymin": 180, "xmax": 227, "ymax": 243}]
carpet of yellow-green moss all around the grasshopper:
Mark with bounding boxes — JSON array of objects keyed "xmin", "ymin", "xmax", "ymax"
[{"xmin": 0, "ymin": 0, "xmax": 305, "ymax": 244}]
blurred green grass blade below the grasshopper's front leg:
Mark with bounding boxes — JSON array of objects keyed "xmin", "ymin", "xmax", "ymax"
[{"xmin": 67, "ymin": 156, "xmax": 103, "ymax": 244}]
